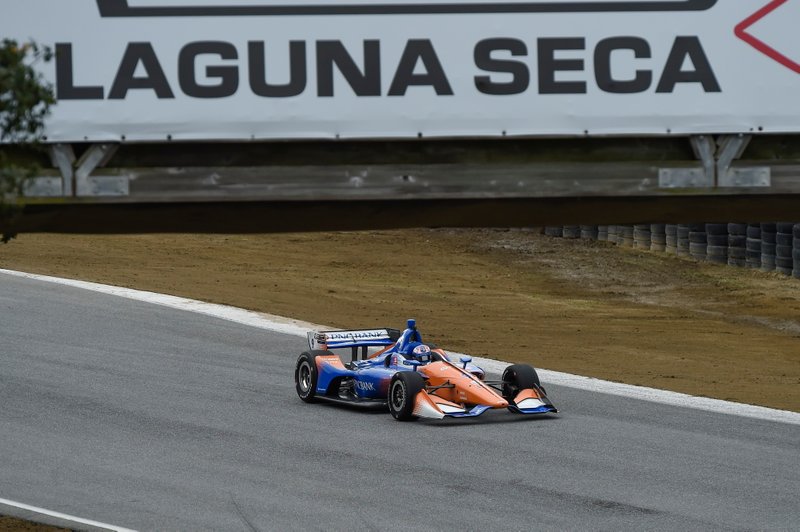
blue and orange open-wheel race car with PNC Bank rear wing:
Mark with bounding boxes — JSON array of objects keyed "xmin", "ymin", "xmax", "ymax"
[{"xmin": 294, "ymin": 319, "xmax": 558, "ymax": 421}]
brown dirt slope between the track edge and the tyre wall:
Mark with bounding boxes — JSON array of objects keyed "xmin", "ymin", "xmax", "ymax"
[{"xmin": 0, "ymin": 230, "xmax": 800, "ymax": 411}]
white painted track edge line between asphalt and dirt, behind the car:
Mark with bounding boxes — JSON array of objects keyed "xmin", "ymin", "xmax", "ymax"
[{"xmin": 0, "ymin": 269, "xmax": 800, "ymax": 425}]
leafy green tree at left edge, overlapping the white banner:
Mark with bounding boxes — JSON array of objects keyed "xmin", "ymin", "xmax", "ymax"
[{"xmin": 0, "ymin": 39, "xmax": 55, "ymax": 243}]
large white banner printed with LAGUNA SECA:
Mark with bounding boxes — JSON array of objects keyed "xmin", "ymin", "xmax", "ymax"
[{"xmin": 0, "ymin": 0, "xmax": 800, "ymax": 142}]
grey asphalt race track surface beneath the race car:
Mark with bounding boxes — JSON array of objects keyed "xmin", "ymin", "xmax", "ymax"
[{"xmin": 0, "ymin": 275, "xmax": 800, "ymax": 531}]
